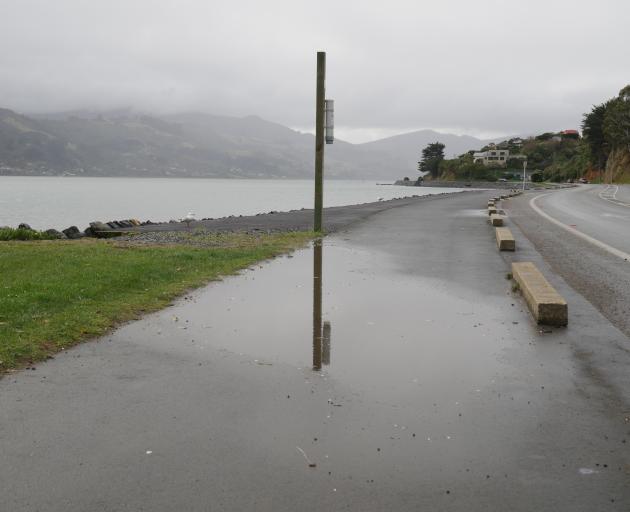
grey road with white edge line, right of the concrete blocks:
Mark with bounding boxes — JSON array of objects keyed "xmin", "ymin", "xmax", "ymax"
[{"xmin": 506, "ymin": 185, "xmax": 630, "ymax": 336}]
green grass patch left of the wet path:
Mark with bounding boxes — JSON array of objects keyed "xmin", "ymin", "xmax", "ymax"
[{"xmin": 0, "ymin": 232, "xmax": 313, "ymax": 373}]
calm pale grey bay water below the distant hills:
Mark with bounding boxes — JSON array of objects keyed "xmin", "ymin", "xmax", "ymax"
[{"xmin": 0, "ymin": 176, "xmax": 464, "ymax": 229}]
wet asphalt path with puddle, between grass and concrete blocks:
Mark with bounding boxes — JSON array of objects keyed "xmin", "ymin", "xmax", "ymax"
[{"xmin": 0, "ymin": 193, "xmax": 630, "ymax": 511}]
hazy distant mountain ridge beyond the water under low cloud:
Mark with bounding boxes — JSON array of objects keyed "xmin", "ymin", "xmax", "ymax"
[{"xmin": 0, "ymin": 109, "xmax": 498, "ymax": 180}]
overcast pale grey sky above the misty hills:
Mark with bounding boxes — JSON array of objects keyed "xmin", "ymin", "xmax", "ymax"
[{"xmin": 0, "ymin": 0, "xmax": 630, "ymax": 142}]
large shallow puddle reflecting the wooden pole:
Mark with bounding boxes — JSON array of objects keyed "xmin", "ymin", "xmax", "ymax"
[{"xmin": 124, "ymin": 237, "xmax": 535, "ymax": 403}]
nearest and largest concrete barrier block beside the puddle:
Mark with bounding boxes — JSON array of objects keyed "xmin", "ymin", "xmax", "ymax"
[{"xmin": 512, "ymin": 261, "xmax": 569, "ymax": 326}]
